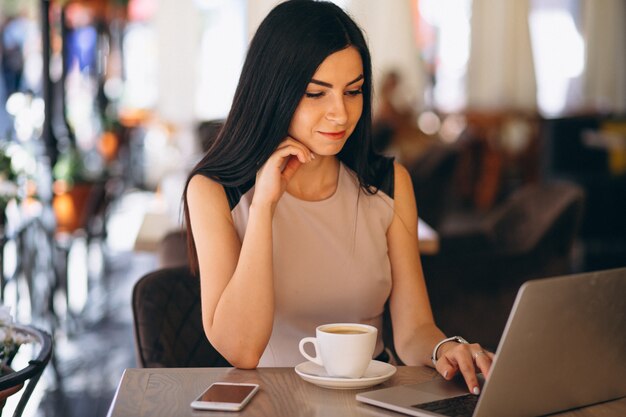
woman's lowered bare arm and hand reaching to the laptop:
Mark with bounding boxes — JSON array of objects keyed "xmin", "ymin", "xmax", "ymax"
[{"xmin": 387, "ymin": 164, "xmax": 491, "ymax": 391}]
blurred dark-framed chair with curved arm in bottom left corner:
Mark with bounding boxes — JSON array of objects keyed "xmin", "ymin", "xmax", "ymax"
[{"xmin": 0, "ymin": 325, "xmax": 52, "ymax": 417}]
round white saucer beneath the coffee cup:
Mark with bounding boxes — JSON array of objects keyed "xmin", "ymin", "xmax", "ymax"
[{"xmin": 295, "ymin": 360, "xmax": 396, "ymax": 389}]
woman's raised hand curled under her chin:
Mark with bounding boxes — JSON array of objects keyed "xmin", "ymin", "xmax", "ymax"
[{"xmin": 253, "ymin": 137, "xmax": 315, "ymax": 209}]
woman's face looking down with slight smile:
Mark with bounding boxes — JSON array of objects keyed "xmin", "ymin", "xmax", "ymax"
[{"xmin": 289, "ymin": 47, "xmax": 364, "ymax": 155}]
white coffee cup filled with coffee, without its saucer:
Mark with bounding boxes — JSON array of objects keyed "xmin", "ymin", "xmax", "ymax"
[{"xmin": 300, "ymin": 323, "xmax": 378, "ymax": 378}]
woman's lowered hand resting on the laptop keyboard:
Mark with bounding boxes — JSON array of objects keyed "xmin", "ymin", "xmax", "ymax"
[{"xmin": 436, "ymin": 342, "xmax": 494, "ymax": 395}]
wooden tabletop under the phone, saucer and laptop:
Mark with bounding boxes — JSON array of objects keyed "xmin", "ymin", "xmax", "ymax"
[{"xmin": 108, "ymin": 366, "xmax": 626, "ymax": 417}]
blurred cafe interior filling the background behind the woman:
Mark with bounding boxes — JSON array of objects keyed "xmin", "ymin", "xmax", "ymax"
[{"xmin": 0, "ymin": 0, "xmax": 626, "ymax": 417}]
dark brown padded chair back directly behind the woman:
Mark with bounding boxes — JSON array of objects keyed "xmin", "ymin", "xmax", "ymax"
[{"xmin": 132, "ymin": 267, "xmax": 231, "ymax": 368}]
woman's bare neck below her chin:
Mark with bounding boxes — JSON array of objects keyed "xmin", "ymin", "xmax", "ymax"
[{"xmin": 287, "ymin": 155, "xmax": 339, "ymax": 201}]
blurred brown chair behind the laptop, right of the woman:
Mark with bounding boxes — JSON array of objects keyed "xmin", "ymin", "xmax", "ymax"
[{"xmin": 422, "ymin": 182, "xmax": 585, "ymax": 349}]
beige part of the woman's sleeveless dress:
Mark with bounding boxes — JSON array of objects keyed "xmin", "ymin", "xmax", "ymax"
[{"xmin": 231, "ymin": 164, "xmax": 393, "ymax": 366}]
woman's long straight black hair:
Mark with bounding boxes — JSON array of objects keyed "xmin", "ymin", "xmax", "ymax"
[{"xmin": 183, "ymin": 0, "xmax": 390, "ymax": 272}]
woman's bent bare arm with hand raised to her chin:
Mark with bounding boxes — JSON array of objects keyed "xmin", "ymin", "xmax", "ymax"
[{"xmin": 187, "ymin": 141, "xmax": 310, "ymax": 368}]
